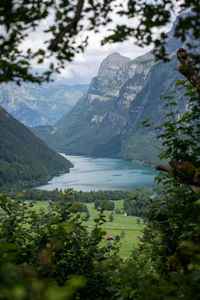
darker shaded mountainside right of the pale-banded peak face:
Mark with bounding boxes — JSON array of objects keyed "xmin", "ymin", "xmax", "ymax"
[{"xmin": 120, "ymin": 57, "xmax": 185, "ymax": 164}]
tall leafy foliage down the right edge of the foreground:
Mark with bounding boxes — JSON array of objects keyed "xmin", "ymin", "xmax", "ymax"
[{"xmin": 122, "ymin": 81, "xmax": 200, "ymax": 299}]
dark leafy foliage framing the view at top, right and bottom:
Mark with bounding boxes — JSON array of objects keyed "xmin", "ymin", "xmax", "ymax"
[{"xmin": 0, "ymin": 0, "xmax": 200, "ymax": 300}]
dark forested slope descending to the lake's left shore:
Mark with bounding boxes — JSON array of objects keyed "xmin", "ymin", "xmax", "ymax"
[{"xmin": 0, "ymin": 107, "xmax": 71, "ymax": 188}]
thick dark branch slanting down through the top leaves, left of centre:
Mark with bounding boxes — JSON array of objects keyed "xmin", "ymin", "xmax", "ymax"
[{"xmin": 48, "ymin": 0, "xmax": 85, "ymax": 52}]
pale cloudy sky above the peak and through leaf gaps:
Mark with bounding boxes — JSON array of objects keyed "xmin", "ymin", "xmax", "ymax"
[{"xmin": 22, "ymin": 1, "xmax": 175, "ymax": 85}]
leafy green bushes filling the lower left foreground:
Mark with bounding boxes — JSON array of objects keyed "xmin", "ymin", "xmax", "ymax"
[{"xmin": 0, "ymin": 192, "xmax": 121, "ymax": 299}]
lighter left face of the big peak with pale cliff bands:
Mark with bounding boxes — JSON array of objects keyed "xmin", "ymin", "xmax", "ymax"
[{"xmin": 34, "ymin": 53, "xmax": 154, "ymax": 156}]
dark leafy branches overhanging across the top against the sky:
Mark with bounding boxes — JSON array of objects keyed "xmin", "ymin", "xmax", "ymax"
[{"xmin": 0, "ymin": 0, "xmax": 200, "ymax": 83}]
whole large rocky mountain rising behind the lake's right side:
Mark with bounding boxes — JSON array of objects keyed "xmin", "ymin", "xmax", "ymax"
[{"xmin": 34, "ymin": 15, "xmax": 185, "ymax": 165}]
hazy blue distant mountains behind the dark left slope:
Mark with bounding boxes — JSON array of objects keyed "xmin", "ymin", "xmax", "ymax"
[{"xmin": 0, "ymin": 82, "xmax": 88, "ymax": 127}]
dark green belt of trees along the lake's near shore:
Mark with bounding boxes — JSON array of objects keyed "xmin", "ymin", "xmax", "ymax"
[{"xmin": 10, "ymin": 185, "xmax": 153, "ymax": 218}]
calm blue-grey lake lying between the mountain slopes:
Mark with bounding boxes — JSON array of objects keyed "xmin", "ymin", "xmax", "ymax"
[{"xmin": 37, "ymin": 154, "xmax": 157, "ymax": 192}]
